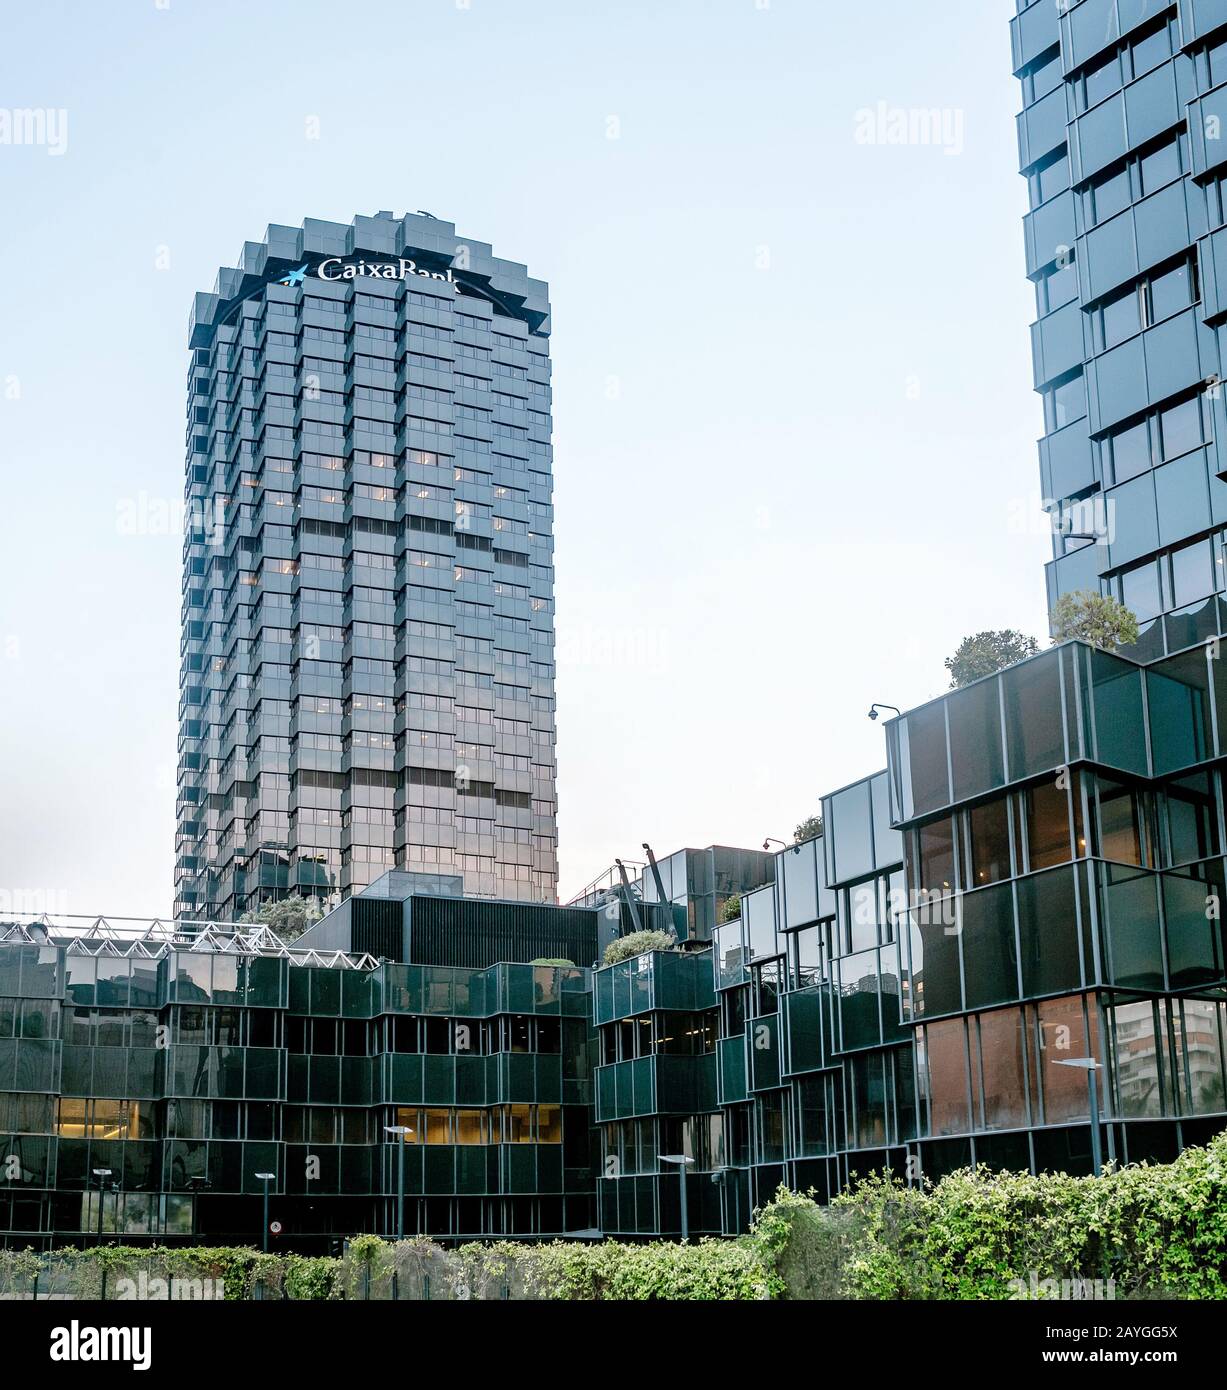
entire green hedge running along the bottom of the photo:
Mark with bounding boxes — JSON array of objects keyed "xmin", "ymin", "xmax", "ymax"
[{"xmin": 0, "ymin": 1133, "xmax": 1227, "ymax": 1300}]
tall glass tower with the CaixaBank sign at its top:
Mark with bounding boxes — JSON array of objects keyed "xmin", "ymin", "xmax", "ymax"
[{"xmin": 175, "ymin": 213, "xmax": 557, "ymax": 920}]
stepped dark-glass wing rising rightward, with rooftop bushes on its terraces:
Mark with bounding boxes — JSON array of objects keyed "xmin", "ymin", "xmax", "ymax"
[{"xmin": 593, "ymin": 642, "xmax": 1227, "ymax": 1236}]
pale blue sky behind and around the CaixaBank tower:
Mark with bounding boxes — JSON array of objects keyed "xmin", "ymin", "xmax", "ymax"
[{"xmin": 0, "ymin": 0, "xmax": 1048, "ymax": 915}]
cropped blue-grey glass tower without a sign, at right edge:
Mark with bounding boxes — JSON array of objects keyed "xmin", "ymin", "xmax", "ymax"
[{"xmin": 1012, "ymin": 0, "xmax": 1227, "ymax": 660}]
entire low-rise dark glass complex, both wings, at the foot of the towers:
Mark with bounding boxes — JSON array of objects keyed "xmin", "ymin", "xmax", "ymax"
[{"xmin": 0, "ymin": 642, "xmax": 1227, "ymax": 1250}]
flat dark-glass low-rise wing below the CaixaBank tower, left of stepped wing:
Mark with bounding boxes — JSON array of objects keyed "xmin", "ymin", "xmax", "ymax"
[{"xmin": 0, "ymin": 929, "xmax": 595, "ymax": 1250}]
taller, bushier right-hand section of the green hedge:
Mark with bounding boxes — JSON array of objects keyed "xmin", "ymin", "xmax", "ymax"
[{"xmin": 755, "ymin": 1133, "xmax": 1227, "ymax": 1298}]
